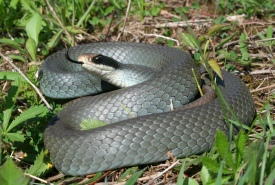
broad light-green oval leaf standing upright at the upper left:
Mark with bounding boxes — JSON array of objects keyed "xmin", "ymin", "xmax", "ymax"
[{"xmin": 26, "ymin": 13, "xmax": 42, "ymax": 47}]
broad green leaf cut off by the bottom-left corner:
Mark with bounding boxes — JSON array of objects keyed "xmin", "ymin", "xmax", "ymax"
[{"xmin": 0, "ymin": 158, "xmax": 30, "ymax": 185}]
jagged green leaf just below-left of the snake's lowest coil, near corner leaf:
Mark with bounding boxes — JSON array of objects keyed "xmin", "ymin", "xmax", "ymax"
[{"xmin": 26, "ymin": 151, "xmax": 52, "ymax": 176}]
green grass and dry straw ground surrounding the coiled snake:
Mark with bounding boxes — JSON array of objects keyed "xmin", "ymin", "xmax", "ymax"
[{"xmin": 0, "ymin": 0, "xmax": 275, "ymax": 185}]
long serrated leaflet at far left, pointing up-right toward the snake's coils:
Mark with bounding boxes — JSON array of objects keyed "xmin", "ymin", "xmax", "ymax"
[{"xmin": 7, "ymin": 105, "xmax": 47, "ymax": 132}]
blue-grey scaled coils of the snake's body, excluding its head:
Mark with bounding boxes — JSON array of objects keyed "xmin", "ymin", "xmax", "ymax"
[{"xmin": 39, "ymin": 42, "xmax": 255, "ymax": 176}]
